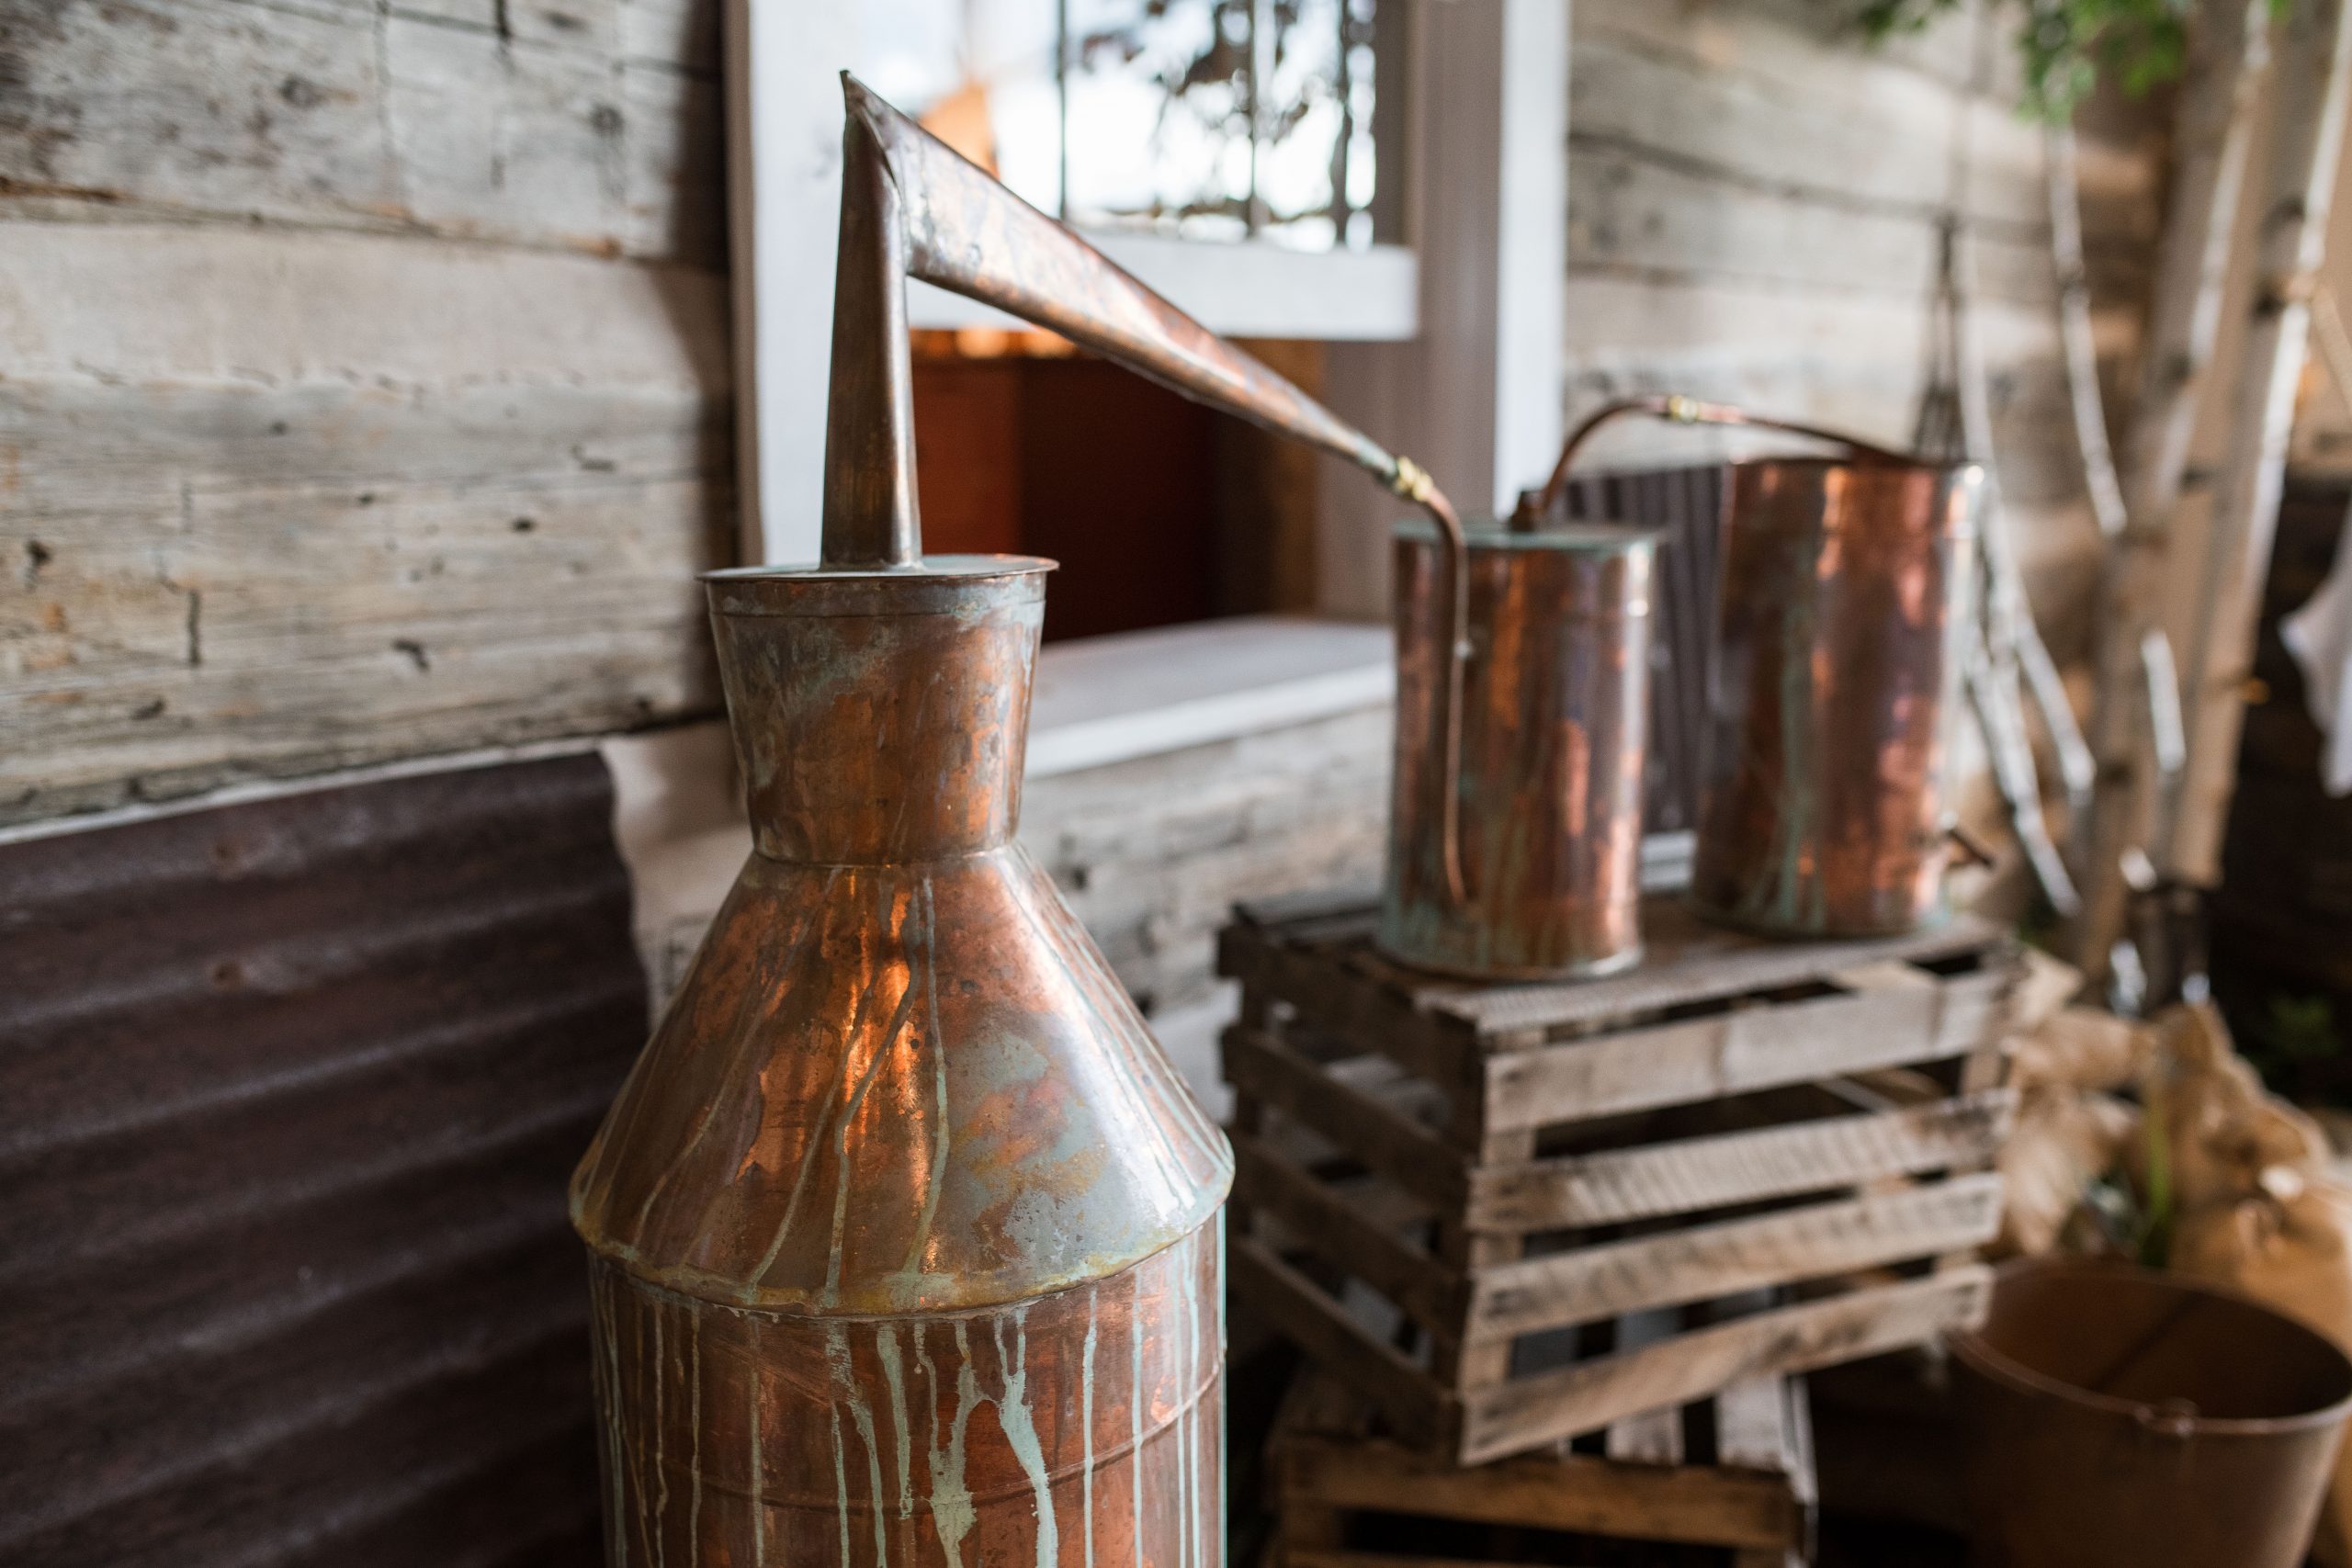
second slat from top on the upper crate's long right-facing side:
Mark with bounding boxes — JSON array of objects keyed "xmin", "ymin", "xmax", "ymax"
[{"xmin": 1467, "ymin": 1089, "xmax": 2016, "ymax": 1232}]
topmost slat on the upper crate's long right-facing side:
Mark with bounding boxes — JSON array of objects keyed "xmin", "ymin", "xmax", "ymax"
[{"xmin": 1487, "ymin": 964, "xmax": 1994, "ymax": 1128}]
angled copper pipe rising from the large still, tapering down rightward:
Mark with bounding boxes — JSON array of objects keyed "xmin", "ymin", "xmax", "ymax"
[{"xmin": 823, "ymin": 71, "xmax": 1470, "ymax": 900}]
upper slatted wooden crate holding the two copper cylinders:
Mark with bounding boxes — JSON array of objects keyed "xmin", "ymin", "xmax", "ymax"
[{"xmin": 1218, "ymin": 898, "xmax": 2016, "ymax": 1464}]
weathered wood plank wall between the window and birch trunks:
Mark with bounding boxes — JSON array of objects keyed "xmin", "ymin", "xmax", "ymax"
[{"xmin": 1566, "ymin": 0, "xmax": 2157, "ymax": 656}]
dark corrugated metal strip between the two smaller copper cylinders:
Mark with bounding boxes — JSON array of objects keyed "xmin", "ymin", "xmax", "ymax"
[{"xmin": 1564, "ymin": 463, "xmax": 1731, "ymax": 832}]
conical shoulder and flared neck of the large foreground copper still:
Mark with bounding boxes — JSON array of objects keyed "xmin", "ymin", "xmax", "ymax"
[{"xmin": 574, "ymin": 558, "xmax": 1230, "ymax": 1314}]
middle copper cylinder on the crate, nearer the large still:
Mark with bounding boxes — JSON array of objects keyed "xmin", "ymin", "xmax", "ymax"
[{"xmin": 1378, "ymin": 520, "xmax": 1654, "ymax": 980}]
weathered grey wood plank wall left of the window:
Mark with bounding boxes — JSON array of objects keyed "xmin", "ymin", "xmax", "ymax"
[{"xmin": 0, "ymin": 0, "xmax": 731, "ymax": 823}]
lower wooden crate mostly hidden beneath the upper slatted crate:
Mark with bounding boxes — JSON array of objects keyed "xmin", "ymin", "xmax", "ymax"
[{"xmin": 1268, "ymin": 1366, "xmax": 1814, "ymax": 1568}]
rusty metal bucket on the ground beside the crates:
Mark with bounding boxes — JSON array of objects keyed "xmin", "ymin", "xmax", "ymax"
[{"xmin": 1952, "ymin": 1260, "xmax": 2352, "ymax": 1568}]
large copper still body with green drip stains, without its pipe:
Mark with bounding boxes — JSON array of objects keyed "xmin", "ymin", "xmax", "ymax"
[{"xmin": 571, "ymin": 558, "xmax": 1232, "ymax": 1568}]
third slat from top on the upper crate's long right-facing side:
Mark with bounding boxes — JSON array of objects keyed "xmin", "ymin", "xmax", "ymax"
[{"xmin": 1463, "ymin": 1170, "xmax": 2002, "ymax": 1342}]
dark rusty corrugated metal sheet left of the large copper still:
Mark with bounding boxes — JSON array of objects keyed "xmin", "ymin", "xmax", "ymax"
[{"xmin": 0, "ymin": 757, "xmax": 644, "ymax": 1568}]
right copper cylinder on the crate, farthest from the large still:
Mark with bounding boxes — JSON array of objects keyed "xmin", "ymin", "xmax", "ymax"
[{"xmin": 1691, "ymin": 456, "xmax": 1985, "ymax": 936}]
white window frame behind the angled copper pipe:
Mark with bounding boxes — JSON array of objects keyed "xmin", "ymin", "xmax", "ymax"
[{"xmin": 727, "ymin": 0, "xmax": 1569, "ymax": 616}]
